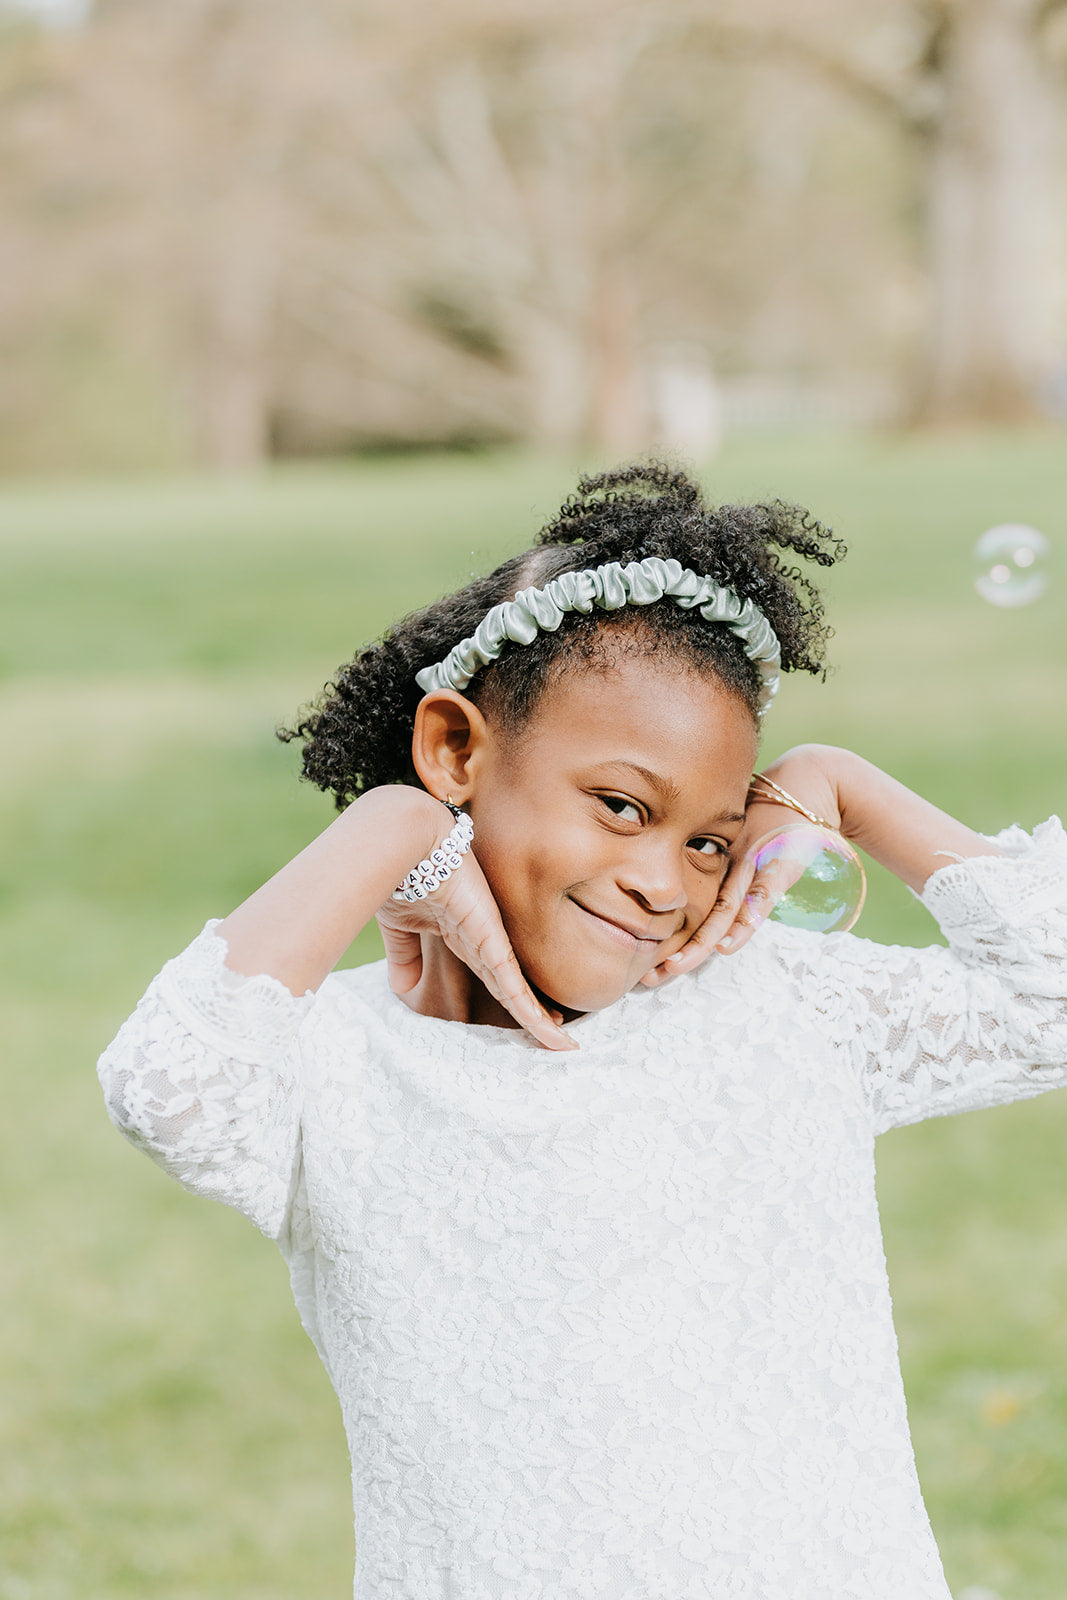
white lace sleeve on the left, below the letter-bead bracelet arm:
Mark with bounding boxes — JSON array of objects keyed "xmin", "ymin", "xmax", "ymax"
[{"xmin": 98, "ymin": 920, "xmax": 315, "ymax": 1238}]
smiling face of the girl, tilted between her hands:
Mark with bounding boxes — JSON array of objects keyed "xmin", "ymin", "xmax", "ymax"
[{"xmin": 467, "ymin": 656, "xmax": 757, "ymax": 1011}]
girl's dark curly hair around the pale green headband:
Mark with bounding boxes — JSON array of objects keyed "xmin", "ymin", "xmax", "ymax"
[{"xmin": 278, "ymin": 462, "xmax": 845, "ymax": 811}]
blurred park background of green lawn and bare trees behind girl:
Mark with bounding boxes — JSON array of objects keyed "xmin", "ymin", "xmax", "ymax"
[{"xmin": 0, "ymin": 0, "xmax": 1067, "ymax": 1600}]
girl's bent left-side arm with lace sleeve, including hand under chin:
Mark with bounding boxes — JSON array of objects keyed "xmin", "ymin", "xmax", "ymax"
[{"xmin": 98, "ymin": 786, "xmax": 573, "ymax": 1238}]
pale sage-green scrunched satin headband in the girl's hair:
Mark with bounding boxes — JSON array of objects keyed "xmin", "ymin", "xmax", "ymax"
[{"xmin": 414, "ymin": 555, "xmax": 782, "ymax": 717}]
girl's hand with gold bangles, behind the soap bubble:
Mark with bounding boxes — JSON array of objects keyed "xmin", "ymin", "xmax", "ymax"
[{"xmin": 641, "ymin": 746, "xmax": 841, "ymax": 989}]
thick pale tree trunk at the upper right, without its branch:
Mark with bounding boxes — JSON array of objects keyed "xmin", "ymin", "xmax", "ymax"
[{"xmin": 917, "ymin": 0, "xmax": 1053, "ymax": 422}]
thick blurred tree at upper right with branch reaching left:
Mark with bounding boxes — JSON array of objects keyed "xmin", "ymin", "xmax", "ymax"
[{"xmin": 705, "ymin": 0, "xmax": 1067, "ymax": 422}]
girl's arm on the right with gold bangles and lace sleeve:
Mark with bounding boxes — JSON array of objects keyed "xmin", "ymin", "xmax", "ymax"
[{"xmin": 649, "ymin": 746, "xmax": 1067, "ymax": 1133}]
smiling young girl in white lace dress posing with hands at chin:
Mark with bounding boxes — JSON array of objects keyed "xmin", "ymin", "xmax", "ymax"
[{"xmin": 99, "ymin": 467, "xmax": 1067, "ymax": 1600}]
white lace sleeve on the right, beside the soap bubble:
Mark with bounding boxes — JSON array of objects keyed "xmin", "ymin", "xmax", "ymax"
[{"xmin": 812, "ymin": 818, "xmax": 1067, "ymax": 1133}]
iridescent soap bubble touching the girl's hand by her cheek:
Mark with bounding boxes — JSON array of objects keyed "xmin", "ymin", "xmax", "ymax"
[{"xmin": 747, "ymin": 822, "xmax": 867, "ymax": 933}]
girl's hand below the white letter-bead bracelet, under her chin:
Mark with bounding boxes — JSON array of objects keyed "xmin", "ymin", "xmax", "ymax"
[{"xmin": 376, "ymin": 829, "xmax": 577, "ymax": 1050}]
